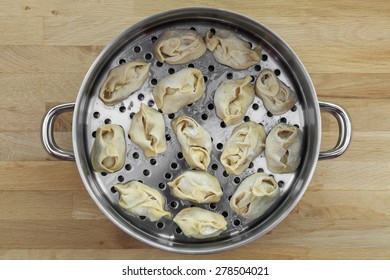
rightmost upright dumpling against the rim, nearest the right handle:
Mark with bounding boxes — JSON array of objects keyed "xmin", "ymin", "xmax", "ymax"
[{"xmin": 265, "ymin": 123, "xmax": 303, "ymax": 173}]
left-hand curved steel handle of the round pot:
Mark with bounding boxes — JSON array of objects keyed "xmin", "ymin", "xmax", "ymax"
[{"xmin": 41, "ymin": 103, "xmax": 75, "ymax": 160}]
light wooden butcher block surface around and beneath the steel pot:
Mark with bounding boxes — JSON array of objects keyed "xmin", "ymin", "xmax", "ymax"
[{"xmin": 0, "ymin": 0, "xmax": 390, "ymax": 259}]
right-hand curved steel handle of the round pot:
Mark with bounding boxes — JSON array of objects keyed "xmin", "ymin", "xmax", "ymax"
[{"xmin": 318, "ymin": 102, "xmax": 352, "ymax": 159}]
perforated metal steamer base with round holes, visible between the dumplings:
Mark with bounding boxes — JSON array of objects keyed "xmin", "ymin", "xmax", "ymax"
[{"xmin": 84, "ymin": 21, "xmax": 305, "ymax": 244}]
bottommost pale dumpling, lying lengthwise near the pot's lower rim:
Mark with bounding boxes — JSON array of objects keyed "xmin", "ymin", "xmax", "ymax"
[{"xmin": 173, "ymin": 207, "xmax": 227, "ymax": 239}]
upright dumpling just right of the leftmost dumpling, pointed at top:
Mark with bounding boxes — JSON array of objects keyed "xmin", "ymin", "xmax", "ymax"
[{"xmin": 129, "ymin": 103, "xmax": 167, "ymax": 157}]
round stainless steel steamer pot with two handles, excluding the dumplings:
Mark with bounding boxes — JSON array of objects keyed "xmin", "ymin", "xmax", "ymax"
[{"xmin": 42, "ymin": 8, "xmax": 352, "ymax": 253}]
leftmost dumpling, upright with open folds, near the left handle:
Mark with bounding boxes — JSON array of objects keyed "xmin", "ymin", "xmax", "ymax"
[{"xmin": 91, "ymin": 124, "xmax": 126, "ymax": 173}]
